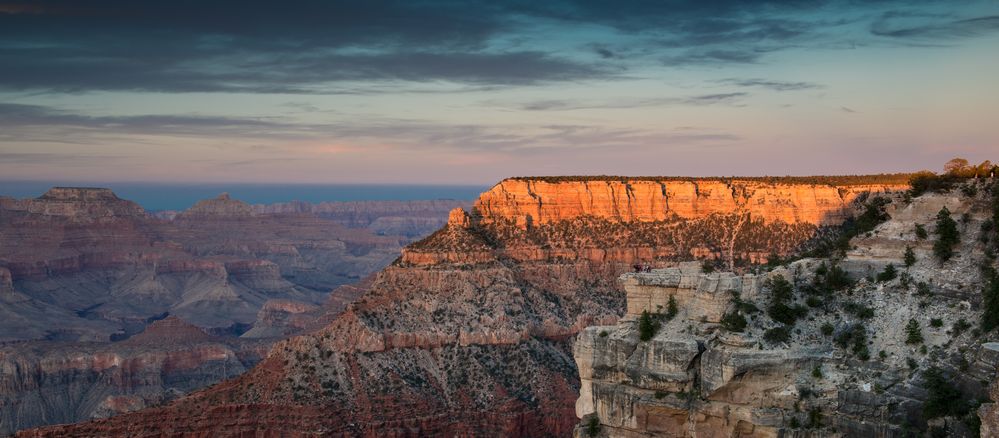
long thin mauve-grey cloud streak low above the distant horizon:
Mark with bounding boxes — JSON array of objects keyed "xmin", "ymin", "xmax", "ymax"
[{"xmin": 0, "ymin": 102, "xmax": 739, "ymax": 154}]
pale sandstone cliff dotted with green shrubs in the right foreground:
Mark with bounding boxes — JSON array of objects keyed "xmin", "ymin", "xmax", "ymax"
[{"xmin": 574, "ymin": 181, "xmax": 999, "ymax": 438}]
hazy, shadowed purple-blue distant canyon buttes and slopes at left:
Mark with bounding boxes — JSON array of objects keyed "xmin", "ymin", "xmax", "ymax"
[{"xmin": 0, "ymin": 188, "xmax": 466, "ymax": 433}]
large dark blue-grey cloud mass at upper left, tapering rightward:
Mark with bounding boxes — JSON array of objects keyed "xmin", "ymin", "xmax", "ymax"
[{"xmin": 0, "ymin": 0, "xmax": 624, "ymax": 93}]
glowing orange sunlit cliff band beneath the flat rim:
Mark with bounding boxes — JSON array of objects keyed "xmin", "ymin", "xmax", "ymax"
[{"xmin": 475, "ymin": 178, "xmax": 903, "ymax": 227}]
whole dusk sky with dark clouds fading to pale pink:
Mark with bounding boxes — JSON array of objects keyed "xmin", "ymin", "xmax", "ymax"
[{"xmin": 0, "ymin": 0, "xmax": 999, "ymax": 184}]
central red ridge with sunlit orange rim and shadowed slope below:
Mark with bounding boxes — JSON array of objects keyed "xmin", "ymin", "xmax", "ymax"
[{"xmin": 15, "ymin": 177, "xmax": 903, "ymax": 436}]
